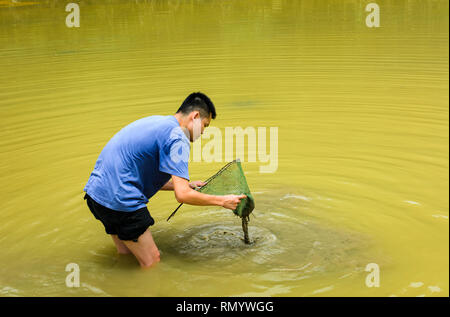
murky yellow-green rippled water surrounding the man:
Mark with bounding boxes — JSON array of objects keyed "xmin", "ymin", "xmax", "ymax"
[{"xmin": 0, "ymin": 0, "xmax": 449, "ymax": 296}]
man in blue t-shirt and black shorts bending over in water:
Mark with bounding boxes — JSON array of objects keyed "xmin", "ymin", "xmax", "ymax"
[{"xmin": 84, "ymin": 92, "xmax": 246, "ymax": 268}]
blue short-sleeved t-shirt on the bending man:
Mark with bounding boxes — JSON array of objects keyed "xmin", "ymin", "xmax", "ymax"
[{"xmin": 84, "ymin": 116, "xmax": 190, "ymax": 211}]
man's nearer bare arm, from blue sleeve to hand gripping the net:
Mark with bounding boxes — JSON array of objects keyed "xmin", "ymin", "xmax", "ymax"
[{"xmin": 171, "ymin": 175, "xmax": 247, "ymax": 210}]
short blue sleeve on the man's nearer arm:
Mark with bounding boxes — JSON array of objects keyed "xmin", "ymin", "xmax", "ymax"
[{"xmin": 159, "ymin": 128, "xmax": 191, "ymax": 180}]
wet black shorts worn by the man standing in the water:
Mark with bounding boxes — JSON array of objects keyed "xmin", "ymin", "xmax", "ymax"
[{"xmin": 84, "ymin": 194, "xmax": 155, "ymax": 242}]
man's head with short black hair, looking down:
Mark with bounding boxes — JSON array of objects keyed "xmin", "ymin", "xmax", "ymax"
[{"xmin": 175, "ymin": 92, "xmax": 216, "ymax": 142}]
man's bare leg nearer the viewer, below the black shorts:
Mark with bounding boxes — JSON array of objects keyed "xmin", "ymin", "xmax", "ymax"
[{"xmin": 121, "ymin": 229, "xmax": 159, "ymax": 268}]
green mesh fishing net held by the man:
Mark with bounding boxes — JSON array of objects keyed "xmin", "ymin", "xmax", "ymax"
[{"xmin": 167, "ymin": 159, "xmax": 255, "ymax": 243}]
